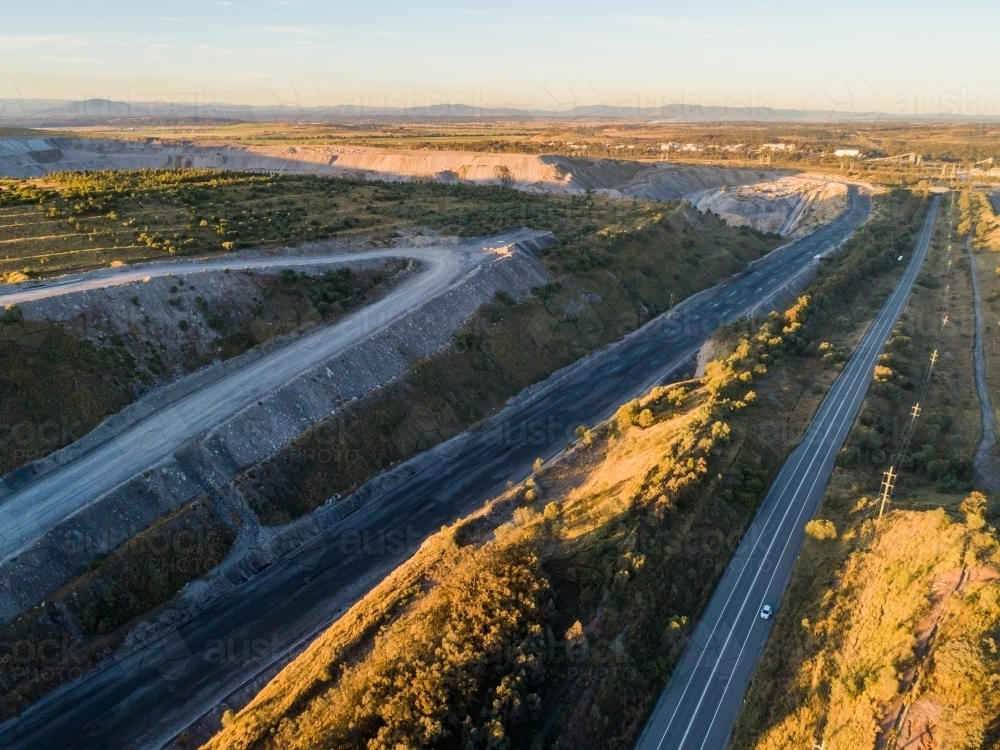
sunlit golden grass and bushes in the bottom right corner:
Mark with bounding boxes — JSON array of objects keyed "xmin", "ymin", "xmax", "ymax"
[{"xmin": 733, "ymin": 509, "xmax": 1000, "ymax": 750}]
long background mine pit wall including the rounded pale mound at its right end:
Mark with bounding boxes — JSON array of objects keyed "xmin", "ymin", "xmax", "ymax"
[{"xmin": 0, "ymin": 138, "xmax": 847, "ymax": 236}]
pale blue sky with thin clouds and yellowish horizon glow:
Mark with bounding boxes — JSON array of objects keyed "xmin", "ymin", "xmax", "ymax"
[{"xmin": 0, "ymin": 0, "xmax": 1000, "ymax": 115}]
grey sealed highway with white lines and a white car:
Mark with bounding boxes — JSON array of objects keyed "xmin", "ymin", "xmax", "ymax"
[{"xmin": 636, "ymin": 196, "xmax": 940, "ymax": 750}]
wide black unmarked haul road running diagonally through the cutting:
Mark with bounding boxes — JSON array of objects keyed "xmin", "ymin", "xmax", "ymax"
[{"xmin": 0, "ymin": 187, "xmax": 871, "ymax": 750}]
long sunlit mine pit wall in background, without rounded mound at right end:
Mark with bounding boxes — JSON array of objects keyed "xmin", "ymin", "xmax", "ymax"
[{"xmin": 0, "ymin": 138, "xmax": 780, "ymax": 200}]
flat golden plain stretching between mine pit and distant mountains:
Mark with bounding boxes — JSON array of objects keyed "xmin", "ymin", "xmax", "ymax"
[{"xmin": 58, "ymin": 121, "xmax": 1000, "ymax": 173}]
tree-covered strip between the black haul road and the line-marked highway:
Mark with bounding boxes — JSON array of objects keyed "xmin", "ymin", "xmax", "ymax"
[{"xmin": 206, "ymin": 192, "xmax": 924, "ymax": 750}]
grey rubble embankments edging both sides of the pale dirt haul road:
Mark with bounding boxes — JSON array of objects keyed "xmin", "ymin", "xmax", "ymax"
[{"xmin": 0, "ymin": 237, "xmax": 552, "ymax": 620}]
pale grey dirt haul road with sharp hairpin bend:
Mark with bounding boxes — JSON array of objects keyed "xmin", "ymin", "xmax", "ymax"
[{"xmin": 0, "ymin": 231, "xmax": 548, "ymax": 561}]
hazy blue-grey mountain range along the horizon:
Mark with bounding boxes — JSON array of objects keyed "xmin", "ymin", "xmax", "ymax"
[{"xmin": 0, "ymin": 99, "xmax": 998, "ymax": 127}]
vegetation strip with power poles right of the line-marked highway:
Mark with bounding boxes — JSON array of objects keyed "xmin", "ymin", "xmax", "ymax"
[{"xmin": 733, "ymin": 195, "xmax": 1000, "ymax": 750}]
